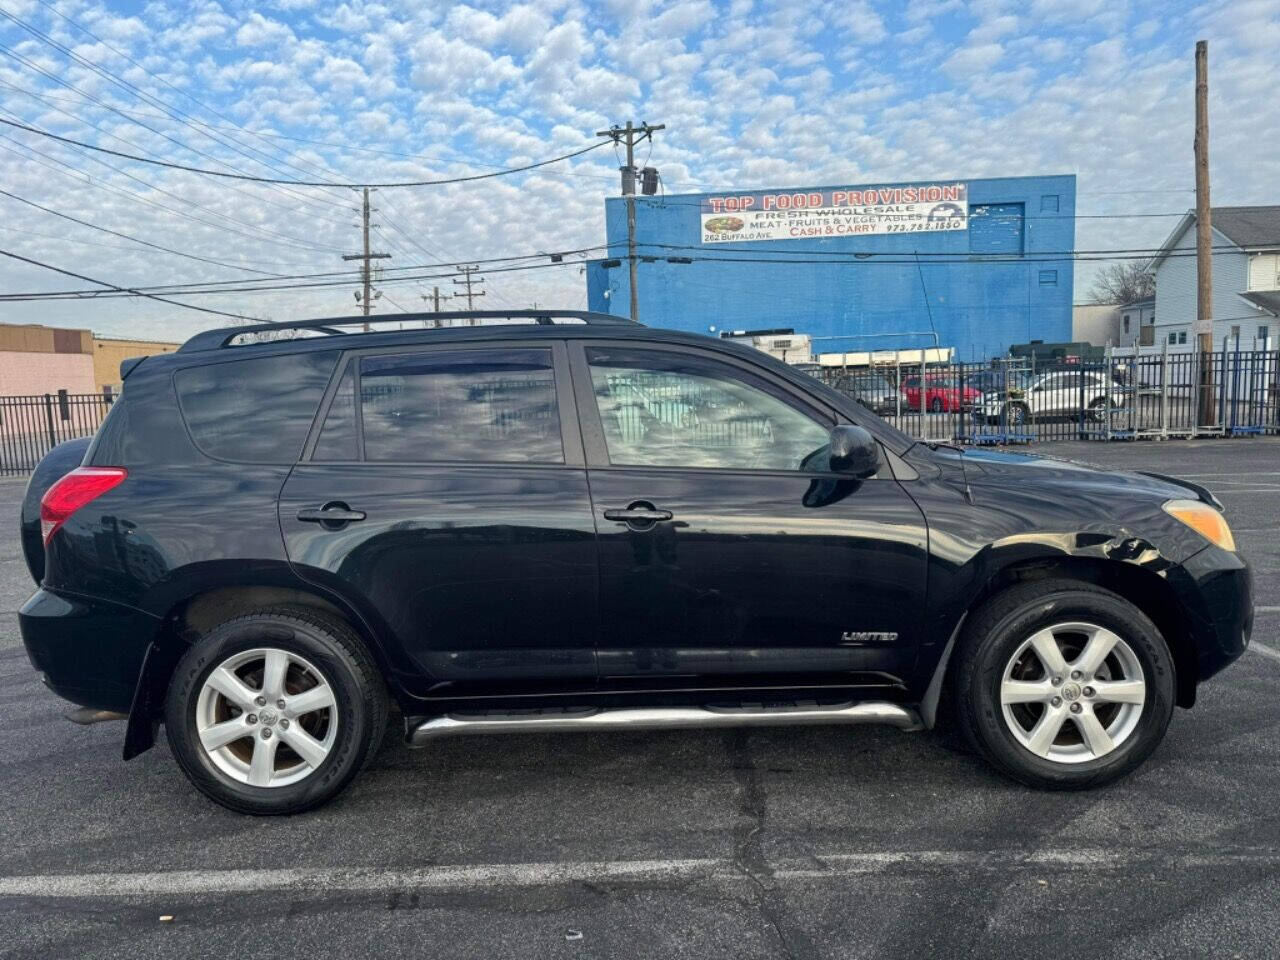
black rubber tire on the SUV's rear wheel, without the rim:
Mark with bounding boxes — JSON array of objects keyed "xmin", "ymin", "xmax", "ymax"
[{"xmin": 165, "ymin": 605, "xmax": 388, "ymax": 815}]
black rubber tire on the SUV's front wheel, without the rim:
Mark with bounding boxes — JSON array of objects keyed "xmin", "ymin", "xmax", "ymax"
[{"xmin": 951, "ymin": 580, "xmax": 1175, "ymax": 790}]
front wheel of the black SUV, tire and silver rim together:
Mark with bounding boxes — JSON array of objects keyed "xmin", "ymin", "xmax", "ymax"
[{"xmin": 955, "ymin": 580, "xmax": 1174, "ymax": 790}]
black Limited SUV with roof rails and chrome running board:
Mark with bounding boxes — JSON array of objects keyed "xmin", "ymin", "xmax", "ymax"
[{"xmin": 20, "ymin": 311, "xmax": 1252, "ymax": 813}]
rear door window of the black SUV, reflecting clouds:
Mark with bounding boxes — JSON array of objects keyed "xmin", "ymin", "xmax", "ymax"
[{"xmin": 355, "ymin": 348, "xmax": 564, "ymax": 463}]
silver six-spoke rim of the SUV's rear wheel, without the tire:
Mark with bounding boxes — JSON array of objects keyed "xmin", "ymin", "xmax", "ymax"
[{"xmin": 196, "ymin": 646, "xmax": 338, "ymax": 787}]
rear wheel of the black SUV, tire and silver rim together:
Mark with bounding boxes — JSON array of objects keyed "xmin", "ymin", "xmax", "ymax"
[{"xmin": 165, "ymin": 607, "xmax": 387, "ymax": 814}]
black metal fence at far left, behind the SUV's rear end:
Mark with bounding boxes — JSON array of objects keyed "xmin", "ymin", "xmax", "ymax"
[{"xmin": 0, "ymin": 390, "xmax": 114, "ymax": 476}]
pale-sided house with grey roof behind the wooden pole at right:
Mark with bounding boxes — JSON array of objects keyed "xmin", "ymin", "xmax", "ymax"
[{"xmin": 1151, "ymin": 206, "xmax": 1280, "ymax": 349}]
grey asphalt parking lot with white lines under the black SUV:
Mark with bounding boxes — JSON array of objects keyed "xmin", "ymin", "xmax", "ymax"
[{"xmin": 0, "ymin": 439, "xmax": 1280, "ymax": 960}]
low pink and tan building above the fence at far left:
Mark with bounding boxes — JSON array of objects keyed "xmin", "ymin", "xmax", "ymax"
[{"xmin": 0, "ymin": 324, "xmax": 178, "ymax": 397}]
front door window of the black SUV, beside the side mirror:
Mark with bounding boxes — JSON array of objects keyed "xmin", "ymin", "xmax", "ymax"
[{"xmin": 588, "ymin": 349, "xmax": 829, "ymax": 470}]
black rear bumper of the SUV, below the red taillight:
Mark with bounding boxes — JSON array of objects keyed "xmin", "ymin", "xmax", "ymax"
[{"xmin": 18, "ymin": 589, "xmax": 160, "ymax": 713}]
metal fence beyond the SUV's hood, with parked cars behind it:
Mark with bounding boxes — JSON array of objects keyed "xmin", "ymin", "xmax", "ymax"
[{"xmin": 812, "ymin": 344, "xmax": 1280, "ymax": 444}]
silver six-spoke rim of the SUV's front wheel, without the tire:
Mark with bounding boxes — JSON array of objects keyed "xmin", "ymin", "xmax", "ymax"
[{"xmin": 1000, "ymin": 622, "xmax": 1147, "ymax": 763}]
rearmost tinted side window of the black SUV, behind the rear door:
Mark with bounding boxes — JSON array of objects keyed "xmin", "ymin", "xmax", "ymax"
[{"xmin": 174, "ymin": 351, "xmax": 338, "ymax": 463}]
